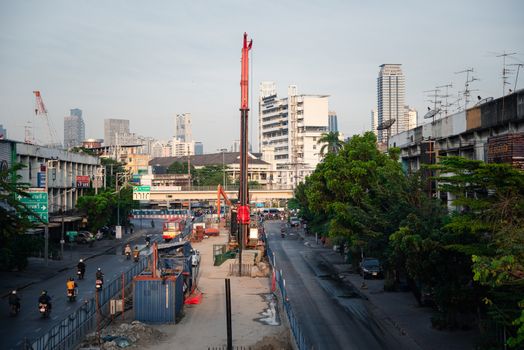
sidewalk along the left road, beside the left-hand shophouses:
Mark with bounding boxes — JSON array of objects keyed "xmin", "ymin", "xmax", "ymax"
[{"xmin": 0, "ymin": 229, "xmax": 147, "ymax": 298}]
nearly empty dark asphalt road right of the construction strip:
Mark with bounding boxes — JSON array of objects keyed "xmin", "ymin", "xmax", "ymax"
[{"xmin": 265, "ymin": 221, "xmax": 412, "ymax": 350}]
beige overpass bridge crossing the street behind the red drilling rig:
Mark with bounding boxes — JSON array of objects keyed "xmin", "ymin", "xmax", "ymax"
[{"xmin": 133, "ymin": 186, "xmax": 293, "ymax": 203}]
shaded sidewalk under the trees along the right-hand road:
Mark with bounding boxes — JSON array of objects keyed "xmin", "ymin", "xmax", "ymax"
[{"xmin": 300, "ymin": 230, "xmax": 479, "ymax": 350}]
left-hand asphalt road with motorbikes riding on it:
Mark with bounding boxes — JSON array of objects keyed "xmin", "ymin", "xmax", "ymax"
[{"xmin": 0, "ymin": 220, "xmax": 166, "ymax": 349}]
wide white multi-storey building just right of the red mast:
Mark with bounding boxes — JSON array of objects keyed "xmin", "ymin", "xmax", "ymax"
[{"xmin": 258, "ymin": 82, "xmax": 328, "ymax": 186}]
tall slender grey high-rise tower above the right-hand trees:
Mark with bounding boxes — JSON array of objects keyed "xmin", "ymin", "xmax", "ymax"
[{"xmin": 377, "ymin": 64, "xmax": 408, "ymax": 142}]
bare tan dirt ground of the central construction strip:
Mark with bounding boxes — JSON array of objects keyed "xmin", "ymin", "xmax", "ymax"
[{"xmin": 142, "ymin": 227, "xmax": 291, "ymax": 350}]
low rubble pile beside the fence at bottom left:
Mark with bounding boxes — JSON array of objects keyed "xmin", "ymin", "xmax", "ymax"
[{"xmin": 80, "ymin": 321, "xmax": 164, "ymax": 350}]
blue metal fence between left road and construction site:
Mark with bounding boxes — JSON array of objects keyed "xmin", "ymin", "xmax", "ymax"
[{"xmin": 24, "ymin": 258, "xmax": 148, "ymax": 350}]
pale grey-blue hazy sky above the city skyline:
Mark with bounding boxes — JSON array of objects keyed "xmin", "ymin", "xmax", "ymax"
[{"xmin": 0, "ymin": 0, "xmax": 524, "ymax": 153}]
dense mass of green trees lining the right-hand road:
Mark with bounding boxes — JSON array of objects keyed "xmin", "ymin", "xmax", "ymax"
[{"xmin": 292, "ymin": 138, "xmax": 524, "ymax": 348}]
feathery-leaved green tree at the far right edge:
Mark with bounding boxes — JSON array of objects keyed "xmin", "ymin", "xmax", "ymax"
[{"xmin": 436, "ymin": 157, "xmax": 524, "ymax": 347}]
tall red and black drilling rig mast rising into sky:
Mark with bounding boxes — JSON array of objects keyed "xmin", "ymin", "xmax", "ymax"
[{"xmin": 237, "ymin": 33, "xmax": 253, "ymax": 276}]
